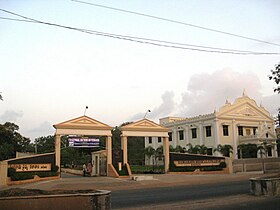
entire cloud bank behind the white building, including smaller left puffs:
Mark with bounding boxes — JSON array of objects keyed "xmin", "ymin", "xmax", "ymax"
[{"xmin": 148, "ymin": 69, "xmax": 280, "ymax": 119}]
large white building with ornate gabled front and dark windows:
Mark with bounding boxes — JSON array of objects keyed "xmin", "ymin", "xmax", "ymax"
[{"xmin": 145, "ymin": 92, "xmax": 278, "ymax": 159}]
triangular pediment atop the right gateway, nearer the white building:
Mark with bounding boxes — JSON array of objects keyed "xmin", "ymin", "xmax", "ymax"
[{"xmin": 121, "ymin": 119, "xmax": 168, "ymax": 131}]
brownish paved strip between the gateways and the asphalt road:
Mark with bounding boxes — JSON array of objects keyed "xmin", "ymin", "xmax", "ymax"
[{"xmin": 1, "ymin": 173, "xmax": 268, "ymax": 191}]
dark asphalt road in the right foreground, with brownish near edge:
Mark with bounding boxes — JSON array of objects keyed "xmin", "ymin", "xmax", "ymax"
[{"xmin": 111, "ymin": 181, "xmax": 280, "ymax": 210}]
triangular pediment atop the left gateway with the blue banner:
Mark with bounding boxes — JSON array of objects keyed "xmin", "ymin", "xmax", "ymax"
[{"xmin": 54, "ymin": 116, "xmax": 112, "ymax": 130}]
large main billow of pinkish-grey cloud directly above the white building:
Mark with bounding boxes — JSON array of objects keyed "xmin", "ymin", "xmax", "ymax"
[{"xmin": 178, "ymin": 69, "xmax": 262, "ymax": 116}]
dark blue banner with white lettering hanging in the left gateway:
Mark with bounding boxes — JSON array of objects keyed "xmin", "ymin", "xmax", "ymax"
[{"xmin": 68, "ymin": 136, "xmax": 100, "ymax": 148}]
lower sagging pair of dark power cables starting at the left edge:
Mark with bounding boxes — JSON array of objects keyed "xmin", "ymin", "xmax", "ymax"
[{"xmin": 0, "ymin": 9, "xmax": 280, "ymax": 55}]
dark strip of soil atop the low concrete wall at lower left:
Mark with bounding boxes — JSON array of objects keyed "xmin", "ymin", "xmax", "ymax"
[{"xmin": 0, "ymin": 188, "xmax": 98, "ymax": 197}]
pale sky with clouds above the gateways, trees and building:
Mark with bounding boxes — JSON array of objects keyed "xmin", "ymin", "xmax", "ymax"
[{"xmin": 0, "ymin": 0, "xmax": 280, "ymax": 140}]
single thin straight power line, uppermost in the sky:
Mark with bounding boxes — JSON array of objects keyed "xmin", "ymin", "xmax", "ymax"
[{"xmin": 71, "ymin": 0, "xmax": 280, "ymax": 46}]
